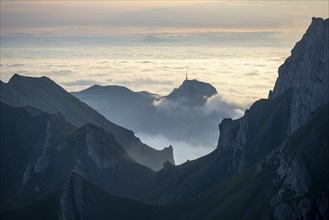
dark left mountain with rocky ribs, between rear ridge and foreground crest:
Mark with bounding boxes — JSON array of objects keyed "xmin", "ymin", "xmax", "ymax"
[{"xmin": 0, "ymin": 102, "xmax": 153, "ymax": 209}]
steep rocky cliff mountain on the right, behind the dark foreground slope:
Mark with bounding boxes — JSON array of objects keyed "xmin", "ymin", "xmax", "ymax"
[{"xmin": 218, "ymin": 18, "xmax": 329, "ymax": 174}]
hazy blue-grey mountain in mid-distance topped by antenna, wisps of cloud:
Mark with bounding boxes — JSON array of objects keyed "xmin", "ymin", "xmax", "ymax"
[{"xmin": 72, "ymin": 80, "xmax": 237, "ymax": 148}]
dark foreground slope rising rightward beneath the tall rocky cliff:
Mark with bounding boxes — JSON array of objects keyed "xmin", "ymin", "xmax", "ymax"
[{"xmin": 164, "ymin": 103, "xmax": 329, "ymax": 219}]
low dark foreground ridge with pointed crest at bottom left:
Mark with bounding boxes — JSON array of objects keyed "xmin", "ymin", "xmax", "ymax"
[{"xmin": 0, "ymin": 172, "xmax": 161, "ymax": 219}]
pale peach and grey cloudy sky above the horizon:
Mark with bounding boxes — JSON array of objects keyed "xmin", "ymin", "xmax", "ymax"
[{"xmin": 1, "ymin": 0, "xmax": 328, "ymax": 35}]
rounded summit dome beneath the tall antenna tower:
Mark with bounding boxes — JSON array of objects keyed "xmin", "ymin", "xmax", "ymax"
[{"xmin": 166, "ymin": 79, "xmax": 217, "ymax": 106}]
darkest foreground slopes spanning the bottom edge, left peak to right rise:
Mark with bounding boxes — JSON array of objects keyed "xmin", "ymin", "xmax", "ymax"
[{"xmin": 0, "ymin": 104, "xmax": 329, "ymax": 219}]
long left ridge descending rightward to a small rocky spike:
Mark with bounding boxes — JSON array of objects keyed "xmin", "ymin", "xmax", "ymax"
[{"xmin": 1, "ymin": 74, "xmax": 174, "ymax": 170}]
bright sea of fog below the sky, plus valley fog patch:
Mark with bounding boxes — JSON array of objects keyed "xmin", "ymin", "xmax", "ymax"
[{"xmin": 0, "ymin": 33, "xmax": 297, "ymax": 164}]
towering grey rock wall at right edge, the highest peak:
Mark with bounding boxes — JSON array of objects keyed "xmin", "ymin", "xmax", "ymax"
[{"xmin": 270, "ymin": 18, "xmax": 329, "ymax": 134}]
